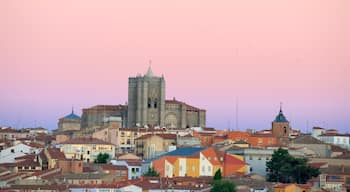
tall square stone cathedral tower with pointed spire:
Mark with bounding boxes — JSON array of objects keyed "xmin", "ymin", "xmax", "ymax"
[{"xmin": 128, "ymin": 67, "xmax": 165, "ymax": 127}]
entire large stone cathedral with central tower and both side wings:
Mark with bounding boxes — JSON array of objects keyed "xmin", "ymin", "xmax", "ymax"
[{"xmin": 75, "ymin": 67, "xmax": 206, "ymax": 129}]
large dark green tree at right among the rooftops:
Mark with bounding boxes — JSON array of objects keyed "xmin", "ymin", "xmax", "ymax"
[{"xmin": 266, "ymin": 148, "xmax": 320, "ymax": 183}]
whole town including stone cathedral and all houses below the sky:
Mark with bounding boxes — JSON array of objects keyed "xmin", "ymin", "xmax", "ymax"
[{"xmin": 0, "ymin": 68, "xmax": 350, "ymax": 192}]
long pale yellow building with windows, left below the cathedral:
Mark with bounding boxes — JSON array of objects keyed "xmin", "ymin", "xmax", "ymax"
[{"xmin": 61, "ymin": 138, "xmax": 115, "ymax": 162}]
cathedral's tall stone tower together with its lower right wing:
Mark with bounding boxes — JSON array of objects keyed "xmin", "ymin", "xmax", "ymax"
[{"xmin": 127, "ymin": 67, "xmax": 206, "ymax": 128}]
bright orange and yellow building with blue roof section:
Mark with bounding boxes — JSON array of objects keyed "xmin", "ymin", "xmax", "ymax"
[{"xmin": 152, "ymin": 147, "xmax": 247, "ymax": 178}]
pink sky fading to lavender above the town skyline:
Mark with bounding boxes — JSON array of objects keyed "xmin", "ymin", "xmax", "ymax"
[{"xmin": 0, "ymin": 0, "xmax": 350, "ymax": 131}]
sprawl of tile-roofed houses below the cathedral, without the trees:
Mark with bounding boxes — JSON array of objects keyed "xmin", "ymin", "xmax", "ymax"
[{"xmin": 0, "ymin": 109, "xmax": 350, "ymax": 192}]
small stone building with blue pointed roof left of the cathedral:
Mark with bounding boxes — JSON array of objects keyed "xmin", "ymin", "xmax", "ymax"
[{"xmin": 58, "ymin": 109, "xmax": 81, "ymax": 132}]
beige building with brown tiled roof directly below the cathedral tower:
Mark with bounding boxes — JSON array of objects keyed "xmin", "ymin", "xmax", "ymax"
[{"xmin": 135, "ymin": 134, "xmax": 176, "ymax": 159}]
